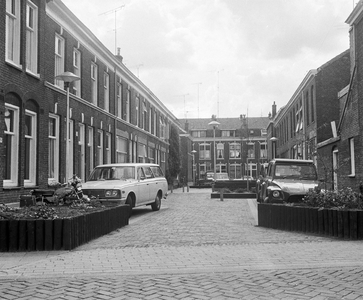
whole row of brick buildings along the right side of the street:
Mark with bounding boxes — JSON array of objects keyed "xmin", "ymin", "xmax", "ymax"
[{"xmin": 267, "ymin": 0, "xmax": 363, "ymax": 191}]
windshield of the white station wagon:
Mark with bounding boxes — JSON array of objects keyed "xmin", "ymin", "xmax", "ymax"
[{"xmin": 89, "ymin": 166, "xmax": 135, "ymax": 181}]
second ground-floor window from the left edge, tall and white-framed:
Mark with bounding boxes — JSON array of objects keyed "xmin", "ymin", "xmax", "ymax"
[{"xmin": 24, "ymin": 110, "xmax": 37, "ymax": 186}]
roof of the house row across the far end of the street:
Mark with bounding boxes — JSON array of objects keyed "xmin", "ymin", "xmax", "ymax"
[{"xmin": 179, "ymin": 117, "xmax": 270, "ymax": 130}]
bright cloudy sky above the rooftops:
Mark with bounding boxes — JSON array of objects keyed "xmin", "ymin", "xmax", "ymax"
[{"xmin": 62, "ymin": 0, "xmax": 358, "ymax": 118}]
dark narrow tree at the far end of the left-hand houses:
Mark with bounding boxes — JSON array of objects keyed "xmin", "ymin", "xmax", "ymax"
[{"xmin": 166, "ymin": 125, "xmax": 180, "ymax": 184}]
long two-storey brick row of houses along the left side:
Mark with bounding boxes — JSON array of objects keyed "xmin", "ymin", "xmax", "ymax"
[{"xmin": 0, "ymin": 0, "xmax": 183, "ymax": 202}]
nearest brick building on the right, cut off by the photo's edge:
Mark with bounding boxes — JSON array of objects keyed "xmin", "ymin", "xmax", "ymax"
[{"xmin": 318, "ymin": 1, "xmax": 363, "ymax": 191}]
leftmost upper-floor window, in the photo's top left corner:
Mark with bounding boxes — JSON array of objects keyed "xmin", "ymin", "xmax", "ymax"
[{"xmin": 5, "ymin": 0, "xmax": 20, "ymax": 66}]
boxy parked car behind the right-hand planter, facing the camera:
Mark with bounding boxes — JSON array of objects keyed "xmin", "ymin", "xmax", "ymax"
[{"xmin": 256, "ymin": 159, "xmax": 318, "ymax": 203}]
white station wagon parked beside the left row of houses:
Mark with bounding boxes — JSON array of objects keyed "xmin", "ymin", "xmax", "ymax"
[{"xmin": 82, "ymin": 163, "xmax": 168, "ymax": 211}]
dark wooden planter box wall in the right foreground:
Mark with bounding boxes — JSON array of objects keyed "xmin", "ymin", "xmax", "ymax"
[{"xmin": 257, "ymin": 203, "xmax": 363, "ymax": 240}]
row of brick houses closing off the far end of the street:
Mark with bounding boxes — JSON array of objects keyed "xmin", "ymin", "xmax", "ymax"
[{"xmin": 179, "ymin": 115, "xmax": 270, "ymax": 182}]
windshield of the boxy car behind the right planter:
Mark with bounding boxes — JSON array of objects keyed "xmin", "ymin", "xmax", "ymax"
[{"xmin": 275, "ymin": 164, "xmax": 317, "ymax": 180}]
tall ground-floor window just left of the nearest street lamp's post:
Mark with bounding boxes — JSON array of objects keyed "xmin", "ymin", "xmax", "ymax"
[{"xmin": 48, "ymin": 114, "xmax": 59, "ymax": 182}]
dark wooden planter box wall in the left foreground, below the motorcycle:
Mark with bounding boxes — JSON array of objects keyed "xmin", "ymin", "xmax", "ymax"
[{"xmin": 0, "ymin": 205, "xmax": 130, "ymax": 252}]
